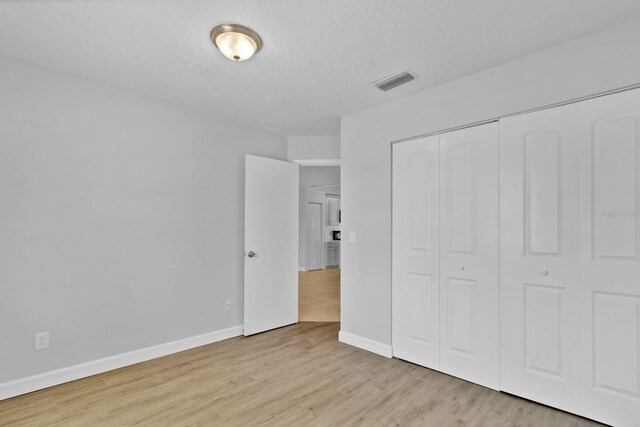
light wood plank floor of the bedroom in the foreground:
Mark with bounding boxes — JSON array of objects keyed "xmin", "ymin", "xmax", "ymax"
[{"xmin": 0, "ymin": 323, "xmax": 598, "ymax": 427}]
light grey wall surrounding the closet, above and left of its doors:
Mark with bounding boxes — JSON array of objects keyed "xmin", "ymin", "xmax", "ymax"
[{"xmin": 341, "ymin": 21, "xmax": 640, "ymax": 348}]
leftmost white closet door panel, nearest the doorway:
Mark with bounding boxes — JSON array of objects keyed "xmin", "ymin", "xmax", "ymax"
[{"xmin": 392, "ymin": 136, "xmax": 440, "ymax": 369}]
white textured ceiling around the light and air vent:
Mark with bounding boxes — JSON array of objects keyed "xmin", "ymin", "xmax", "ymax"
[{"xmin": 0, "ymin": 0, "xmax": 640, "ymax": 135}]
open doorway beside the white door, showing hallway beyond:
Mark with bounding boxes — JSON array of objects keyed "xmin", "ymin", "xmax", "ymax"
[{"xmin": 298, "ymin": 166, "xmax": 342, "ymax": 322}]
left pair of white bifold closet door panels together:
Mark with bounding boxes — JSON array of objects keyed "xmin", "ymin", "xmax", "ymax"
[{"xmin": 393, "ymin": 123, "xmax": 499, "ymax": 389}]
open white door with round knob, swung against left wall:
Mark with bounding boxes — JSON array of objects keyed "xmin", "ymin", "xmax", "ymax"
[{"xmin": 244, "ymin": 155, "xmax": 299, "ymax": 335}]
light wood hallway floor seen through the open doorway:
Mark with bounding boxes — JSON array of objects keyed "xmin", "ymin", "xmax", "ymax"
[{"xmin": 298, "ymin": 268, "xmax": 340, "ymax": 322}]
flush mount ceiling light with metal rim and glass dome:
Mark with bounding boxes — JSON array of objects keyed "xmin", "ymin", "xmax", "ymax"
[{"xmin": 211, "ymin": 24, "xmax": 262, "ymax": 62}]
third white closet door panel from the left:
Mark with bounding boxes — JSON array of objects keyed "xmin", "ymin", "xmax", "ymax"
[{"xmin": 500, "ymin": 104, "xmax": 580, "ymax": 412}]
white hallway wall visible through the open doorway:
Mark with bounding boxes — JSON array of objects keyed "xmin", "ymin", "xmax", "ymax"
[{"xmin": 298, "ymin": 166, "xmax": 340, "ymax": 269}]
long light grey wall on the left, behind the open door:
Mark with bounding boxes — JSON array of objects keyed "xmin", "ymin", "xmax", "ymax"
[{"xmin": 0, "ymin": 58, "xmax": 287, "ymax": 383}]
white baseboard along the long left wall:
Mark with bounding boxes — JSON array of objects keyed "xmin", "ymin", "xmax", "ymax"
[{"xmin": 0, "ymin": 325, "xmax": 244, "ymax": 400}]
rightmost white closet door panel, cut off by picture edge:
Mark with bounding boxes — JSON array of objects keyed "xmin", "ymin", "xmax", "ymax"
[{"xmin": 579, "ymin": 90, "xmax": 640, "ymax": 426}]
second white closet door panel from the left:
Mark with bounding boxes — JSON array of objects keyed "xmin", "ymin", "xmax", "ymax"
[{"xmin": 440, "ymin": 123, "xmax": 500, "ymax": 389}]
